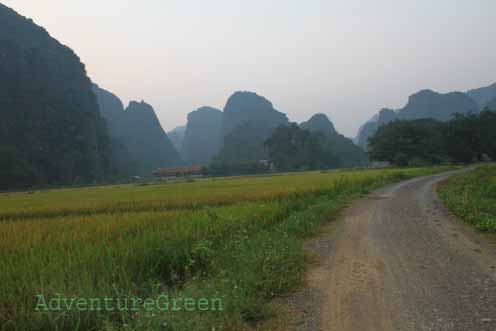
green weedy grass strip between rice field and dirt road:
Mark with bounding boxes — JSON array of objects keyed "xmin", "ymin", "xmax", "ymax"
[{"xmin": 112, "ymin": 190, "xmax": 352, "ymax": 331}]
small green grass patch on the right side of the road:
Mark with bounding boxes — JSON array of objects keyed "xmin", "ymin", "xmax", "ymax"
[{"xmin": 438, "ymin": 163, "xmax": 496, "ymax": 232}]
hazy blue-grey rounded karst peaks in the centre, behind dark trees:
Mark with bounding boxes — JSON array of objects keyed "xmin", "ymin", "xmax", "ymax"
[{"xmin": 176, "ymin": 91, "xmax": 367, "ymax": 167}]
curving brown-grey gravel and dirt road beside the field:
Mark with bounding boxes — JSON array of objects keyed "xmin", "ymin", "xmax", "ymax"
[{"xmin": 296, "ymin": 173, "xmax": 496, "ymax": 331}]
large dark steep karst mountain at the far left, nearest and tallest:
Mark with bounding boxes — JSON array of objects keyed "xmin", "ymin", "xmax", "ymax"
[{"xmin": 0, "ymin": 4, "xmax": 109, "ymax": 189}]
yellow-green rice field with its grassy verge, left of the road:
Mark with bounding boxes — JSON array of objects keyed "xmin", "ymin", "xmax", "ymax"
[{"xmin": 0, "ymin": 167, "xmax": 456, "ymax": 330}]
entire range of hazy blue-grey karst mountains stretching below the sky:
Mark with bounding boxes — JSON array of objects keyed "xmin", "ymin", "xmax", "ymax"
[{"xmin": 0, "ymin": 5, "xmax": 496, "ymax": 188}]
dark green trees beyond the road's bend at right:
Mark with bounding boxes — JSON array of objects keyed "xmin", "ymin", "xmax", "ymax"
[{"xmin": 368, "ymin": 108, "xmax": 496, "ymax": 166}]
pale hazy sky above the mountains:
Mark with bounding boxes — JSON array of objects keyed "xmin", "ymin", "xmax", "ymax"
[{"xmin": 0, "ymin": 0, "xmax": 496, "ymax": 136}]
